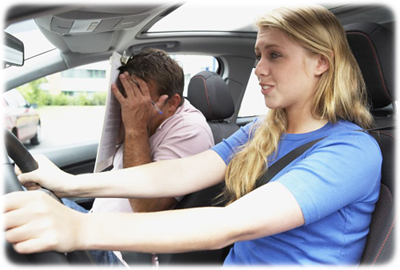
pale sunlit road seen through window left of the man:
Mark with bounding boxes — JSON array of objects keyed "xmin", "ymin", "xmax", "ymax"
[{"xmin": 25, "ymin": 106, "xmax": 105, "ymax": 149}]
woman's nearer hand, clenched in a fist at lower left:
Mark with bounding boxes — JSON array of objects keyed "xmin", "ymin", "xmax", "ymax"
[{"xmin": 3, "ymin": 191, "xmax": 84, "ymax": 254}]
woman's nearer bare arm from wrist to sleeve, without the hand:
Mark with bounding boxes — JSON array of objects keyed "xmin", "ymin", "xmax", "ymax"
[{"xmin": 77, "ymin": 183, "xmax": 304, "ymax": 253}]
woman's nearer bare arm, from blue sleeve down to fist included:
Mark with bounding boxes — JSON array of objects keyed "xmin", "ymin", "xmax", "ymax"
[{"xmin": 4, "ymin": 183, "xmax": 304, "ymax": 253}]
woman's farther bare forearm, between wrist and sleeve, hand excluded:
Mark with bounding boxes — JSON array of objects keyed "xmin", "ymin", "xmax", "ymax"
[{"xmin": 65, "ymin": 150, "xmax": 226, "ymax": 199}]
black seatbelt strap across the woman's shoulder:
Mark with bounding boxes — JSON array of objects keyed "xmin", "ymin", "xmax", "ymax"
[{"xmin": 256, "ymin": 137, "xmax": 325, "ymax": 188}]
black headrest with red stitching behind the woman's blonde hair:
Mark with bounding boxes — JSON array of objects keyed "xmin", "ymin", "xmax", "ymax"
[{"xmin": 344, "ymin": 22, "xmax": 395, "ymax": 109}]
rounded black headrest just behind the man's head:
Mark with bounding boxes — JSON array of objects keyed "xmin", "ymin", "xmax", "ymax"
[{"xmin": 187, "ymin": 71, "xmax": 235, "ymax": 121}]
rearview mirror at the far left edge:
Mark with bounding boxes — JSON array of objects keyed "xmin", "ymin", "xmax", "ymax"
[{"xmin": 3, "ymin": 32, "xmax": 24, "ymax": 66}]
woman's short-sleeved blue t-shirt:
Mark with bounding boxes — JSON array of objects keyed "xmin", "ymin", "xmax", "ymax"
[{"xmin": 212, "ymin": 121, "xmax": 382, "ymax": 265}]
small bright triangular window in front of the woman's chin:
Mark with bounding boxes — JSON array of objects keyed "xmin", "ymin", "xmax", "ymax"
[{"xmin": 238, "ymin": 69, "xmax": 268, "ymax": 117}]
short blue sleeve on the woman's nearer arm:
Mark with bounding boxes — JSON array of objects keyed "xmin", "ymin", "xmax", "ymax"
[{"xmin": 276, "ymin": 132, "xmax": 382, "ymax": 225}]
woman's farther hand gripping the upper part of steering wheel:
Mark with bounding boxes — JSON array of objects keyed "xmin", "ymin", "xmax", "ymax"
[{"xmin": 15, "ymin": 155, "xmax": 74, "ymax": 198}]
